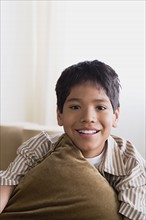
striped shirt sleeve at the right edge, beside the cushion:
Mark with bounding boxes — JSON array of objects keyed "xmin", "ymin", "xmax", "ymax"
[{"xmin": 115, "ymin": 158, "xmax": 146, "ymax": 220}]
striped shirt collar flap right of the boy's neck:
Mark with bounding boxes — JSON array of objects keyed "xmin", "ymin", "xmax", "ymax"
[{"xmin": 99, "ymin": 136, "xmax": 126, "ymax": 176}]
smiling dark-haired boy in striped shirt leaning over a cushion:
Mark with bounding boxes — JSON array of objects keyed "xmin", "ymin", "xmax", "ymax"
[{"xmin": 1, "ymin": 60, "xmax": 146, "ymax": 220}]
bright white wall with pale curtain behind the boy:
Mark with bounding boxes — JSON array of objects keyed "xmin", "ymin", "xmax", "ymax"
[{"xmin": 1, "ymin": 1, "xmax": 145, "ymax": 156}]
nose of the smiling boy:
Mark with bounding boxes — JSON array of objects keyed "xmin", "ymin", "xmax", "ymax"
[{"xmin": 81, "ymin": 110, "xmax": 97, "ymax": 123}]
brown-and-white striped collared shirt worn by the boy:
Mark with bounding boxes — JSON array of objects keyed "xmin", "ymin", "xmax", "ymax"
[{"xmin": 0, "ymin": 132, "xmax": 146, "ymax": 220}]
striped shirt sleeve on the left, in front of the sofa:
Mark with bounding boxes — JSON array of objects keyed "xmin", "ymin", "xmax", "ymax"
[{"xmin": 0, "ymin": 132, "xmax": 56, "ymax": 185}]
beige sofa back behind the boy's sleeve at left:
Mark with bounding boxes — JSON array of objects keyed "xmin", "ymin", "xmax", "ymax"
[{"xmin": 0, "ymin": 125, "xmax": 61, "ymax": 170}]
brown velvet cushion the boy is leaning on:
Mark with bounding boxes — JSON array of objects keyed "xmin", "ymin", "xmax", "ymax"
[{"xmin": 0, "ymin": 135, "xmax": 122, "ymax": 220}]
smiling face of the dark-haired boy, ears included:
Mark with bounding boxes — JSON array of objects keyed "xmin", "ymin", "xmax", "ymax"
[{"xmin": 57, "ymin": 82, "xmax": 119, "ymax": 158}]
